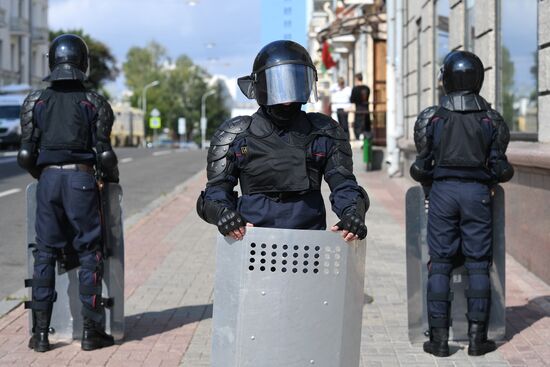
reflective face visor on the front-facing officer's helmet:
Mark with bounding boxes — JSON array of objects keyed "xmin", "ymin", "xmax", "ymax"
[{"xmin": 255, "ymin": 64, "xmax": 317, "ymax": 106}]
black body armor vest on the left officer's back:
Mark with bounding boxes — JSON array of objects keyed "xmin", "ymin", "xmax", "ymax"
[{"xmin": 40, "ymin": 88, "xmax": 92, "ymax": 150}]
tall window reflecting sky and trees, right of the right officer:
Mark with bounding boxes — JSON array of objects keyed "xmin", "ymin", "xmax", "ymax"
[{"xmin": 499, "ymin": 0, "xmax": 538, "ymax": 133}]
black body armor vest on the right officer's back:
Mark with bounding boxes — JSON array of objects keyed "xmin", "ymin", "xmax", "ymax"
[{"xmin": 434, "ymin": 108, "xmax": 491, "ymax": 168}]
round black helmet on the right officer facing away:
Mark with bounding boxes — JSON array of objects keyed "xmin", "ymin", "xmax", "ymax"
[{"xmin": 439, "ymin": 51, "xmax": 485, "ymax": 94}]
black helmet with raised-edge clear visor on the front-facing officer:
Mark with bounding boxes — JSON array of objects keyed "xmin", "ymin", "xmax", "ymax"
[{"xmin": 238, "ymin": 41, "xmax": 317, "ymax": 106}]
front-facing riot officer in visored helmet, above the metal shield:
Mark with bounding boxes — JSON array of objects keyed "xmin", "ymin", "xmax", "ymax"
[{"xmin": 197, "ymin": 41, "xmax": 369, "ymax": 241}]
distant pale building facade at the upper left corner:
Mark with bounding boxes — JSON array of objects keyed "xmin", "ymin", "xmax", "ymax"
[{"xmin": 0, "ymin": 0, "xmax": 49, "ymax": 87}]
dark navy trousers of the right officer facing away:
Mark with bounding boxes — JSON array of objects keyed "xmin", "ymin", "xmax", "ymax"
[{"xmin": 427, "ymin": 179, "xmax": 492, "ymax": 327}]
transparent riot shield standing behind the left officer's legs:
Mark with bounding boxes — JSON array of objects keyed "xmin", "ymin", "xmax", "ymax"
[{"xmin": 27, "ymin": 183, "xmax": 124, "ymax": 342}]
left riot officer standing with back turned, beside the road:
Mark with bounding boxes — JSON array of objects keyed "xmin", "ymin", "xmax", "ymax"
[{"xmin": 17, "ymin": 34, "xmax": 118, "ymax": 352}]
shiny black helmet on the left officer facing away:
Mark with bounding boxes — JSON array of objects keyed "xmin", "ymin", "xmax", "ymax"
[{"xmin": 44, "ymin": 34, "xmax": 88, "ymax": 82}]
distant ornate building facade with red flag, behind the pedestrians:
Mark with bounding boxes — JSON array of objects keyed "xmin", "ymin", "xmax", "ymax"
[{"xmin": 308, "ymin": 0, "xmax": 387, "ymax": 141}]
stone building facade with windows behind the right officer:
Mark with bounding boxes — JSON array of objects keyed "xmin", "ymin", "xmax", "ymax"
[{"xmin": 386, "ymin": 0, "xmax": 550, "ymax": 283}]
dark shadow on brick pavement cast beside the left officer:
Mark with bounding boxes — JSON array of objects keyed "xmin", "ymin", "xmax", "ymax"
[{"xmin": 124, "ymin": 303, "xmax": 212, "ymax": 342}]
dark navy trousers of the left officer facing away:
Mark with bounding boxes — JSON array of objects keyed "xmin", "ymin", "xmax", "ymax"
[{"xmin": 32, "ymin": 169, "xmax": 103, "ymax": 322}]
